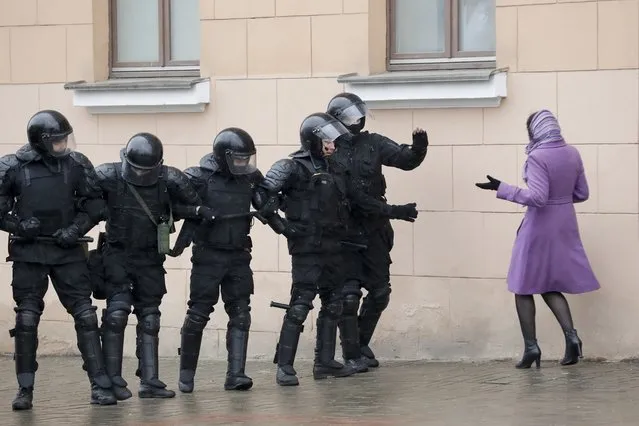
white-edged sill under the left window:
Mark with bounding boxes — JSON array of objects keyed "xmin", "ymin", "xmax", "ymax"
[{"xmin": 64, "ymin": 77, "xmax": 211, "ymax": 114}]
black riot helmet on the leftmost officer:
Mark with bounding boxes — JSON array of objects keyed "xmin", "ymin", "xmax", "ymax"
[{"xmin": 27, "ymin": 110, "xmax": 75, "ymax": 158}]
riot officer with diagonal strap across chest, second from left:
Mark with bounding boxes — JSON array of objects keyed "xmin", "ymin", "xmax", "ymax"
[{"xmin": 94, "ymin": 133, "xmax": 210, "ymax": 400}]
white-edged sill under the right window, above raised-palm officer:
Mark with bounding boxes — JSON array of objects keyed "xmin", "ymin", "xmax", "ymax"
[{"xmin": 337, "ymin": 68, "xmax": 508, "ymax": 109}]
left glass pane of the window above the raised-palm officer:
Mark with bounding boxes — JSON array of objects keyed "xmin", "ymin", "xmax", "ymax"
[{"xmin": 393, "ymin": 0, "xmax": 446, "ymax": 53}]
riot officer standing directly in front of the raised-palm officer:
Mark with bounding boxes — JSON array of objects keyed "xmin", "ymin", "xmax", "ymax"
[{"xmin": 258, "ymin": 113, "xmax": 362, "ymax": 386}]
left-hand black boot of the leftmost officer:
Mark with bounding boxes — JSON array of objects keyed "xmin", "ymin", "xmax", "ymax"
[{"xmin": 9, "ymin": 311, "xmax": 40, "ymax": 410}]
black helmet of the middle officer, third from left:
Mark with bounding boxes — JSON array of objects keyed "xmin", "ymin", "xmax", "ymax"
[{"xmin": 213, "ymin": 127, "xmax": 257, "ymax": 175}]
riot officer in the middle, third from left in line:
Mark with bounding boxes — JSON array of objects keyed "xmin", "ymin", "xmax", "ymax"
[{"xmin": 174, "ymin": 127, "xmax": 263, "ymax": 393}]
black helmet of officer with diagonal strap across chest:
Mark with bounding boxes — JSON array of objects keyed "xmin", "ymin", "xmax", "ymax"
[{"xmin": 120, "ymin": 133, "xmax": 164, "ymax": 186}]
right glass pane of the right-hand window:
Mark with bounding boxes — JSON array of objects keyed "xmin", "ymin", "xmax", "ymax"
[{"xmin": 459, "ymin": 0, "xmax": 496, "ymax": 52}]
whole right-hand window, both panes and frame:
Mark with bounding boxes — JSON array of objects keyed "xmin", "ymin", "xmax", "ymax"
[{"xmin": 387, "ymin": 0, "xmax": 496, "ymax": 70}]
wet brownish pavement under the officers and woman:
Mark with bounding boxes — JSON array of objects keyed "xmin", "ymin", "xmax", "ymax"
[{"xmin": 0, "ymin": 357, "xmax": 639, "ymax": 426}]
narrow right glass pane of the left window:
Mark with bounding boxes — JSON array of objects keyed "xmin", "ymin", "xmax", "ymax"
[{"xmin": 171, "ymin": 0, "xmax": 200, "ymax": 61}]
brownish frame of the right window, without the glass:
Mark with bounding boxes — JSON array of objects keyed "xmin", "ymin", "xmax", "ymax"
[{"xmin": 386, "ymin": 0, "xmax": 496, "ymax": 71}]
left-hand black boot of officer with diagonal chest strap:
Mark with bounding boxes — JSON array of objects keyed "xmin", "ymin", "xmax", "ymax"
[{"xmin": 102, "ymin": 309, "xmax": 133, "ymax": 401}]
